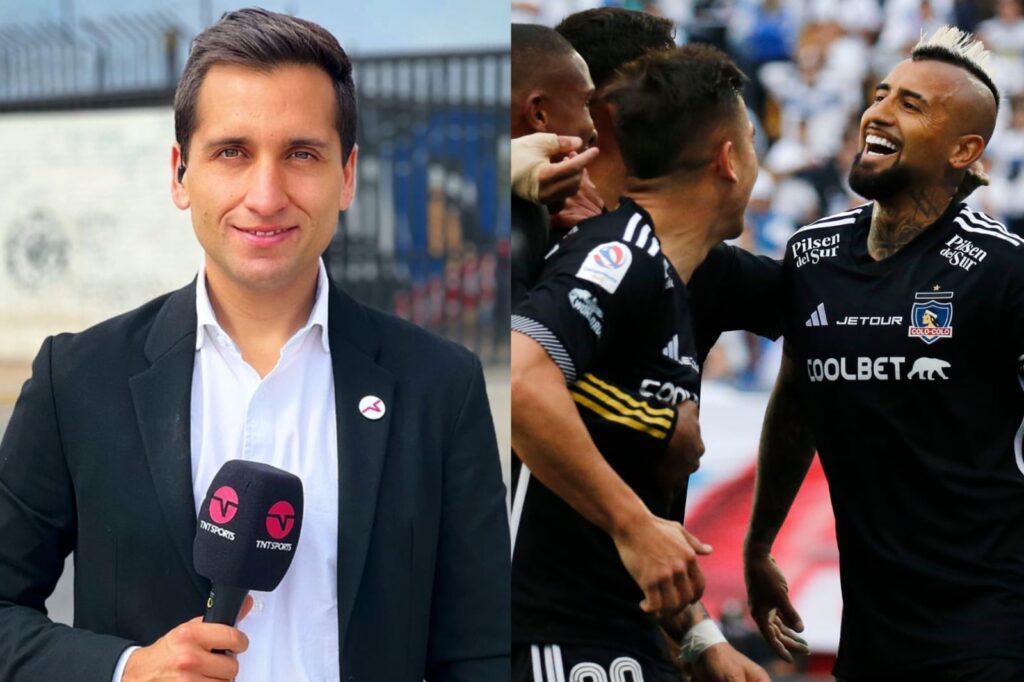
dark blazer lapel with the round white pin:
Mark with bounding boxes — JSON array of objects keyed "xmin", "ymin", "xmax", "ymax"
[{"xmin": 328, "ymin": 284, "xmax": 395, "ymax": 643}]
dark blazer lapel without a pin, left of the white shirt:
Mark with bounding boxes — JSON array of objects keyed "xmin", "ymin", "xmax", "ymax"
[{"xmin": 128, "ymin": 282, "xmax": 210, "ymax": 598}]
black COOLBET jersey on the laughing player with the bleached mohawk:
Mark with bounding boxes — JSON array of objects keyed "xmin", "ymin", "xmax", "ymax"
[{"xmin": 780, "ymin": 199, "xmax": 1024, "ymax": 677}]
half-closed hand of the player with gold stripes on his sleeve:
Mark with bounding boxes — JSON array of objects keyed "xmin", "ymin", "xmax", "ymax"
[{"xmin": 612, "ymin": 513, "xmax": 711, "ymax": 617}]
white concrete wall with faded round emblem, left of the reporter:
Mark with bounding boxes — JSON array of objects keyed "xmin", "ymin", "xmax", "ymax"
[{"xmin": 0, "ymin": 108, "xmax": 202, "ymax": 364}]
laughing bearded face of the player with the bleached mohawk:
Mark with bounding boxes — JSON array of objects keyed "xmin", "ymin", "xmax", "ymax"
[{"xmin": 850, "ymin": 59, "xmax": 994, "ymax": 200}]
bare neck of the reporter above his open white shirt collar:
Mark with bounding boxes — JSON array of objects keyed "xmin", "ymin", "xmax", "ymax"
[{"xmin": 206, "ymin": 261, "xmax": 317, "ymax": 377}]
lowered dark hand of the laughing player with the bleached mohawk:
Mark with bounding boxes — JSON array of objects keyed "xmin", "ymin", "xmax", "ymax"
[{"xmin": 743, "ymin": 551, "xmax": 811, "ymax": 663}]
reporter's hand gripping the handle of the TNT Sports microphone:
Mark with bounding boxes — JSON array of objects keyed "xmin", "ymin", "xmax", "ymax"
[{"xmin": 121, "ymin": 596, "xmax": 253, "ymax": 682}]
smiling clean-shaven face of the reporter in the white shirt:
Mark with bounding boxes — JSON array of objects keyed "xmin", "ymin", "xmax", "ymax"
[{"xmin": 172, "ymin": 65, "xmax": 356, "ymax": 292}]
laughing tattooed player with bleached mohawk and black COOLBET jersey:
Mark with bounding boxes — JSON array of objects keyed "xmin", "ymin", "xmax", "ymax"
[{"xmin": 744, "ymin": 27, "xmax": 1024, "ymax": 682}]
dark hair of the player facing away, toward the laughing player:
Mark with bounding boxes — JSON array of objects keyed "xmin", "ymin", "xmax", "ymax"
[{"xmin": 604, "ymin": 44, "xmax": 746, "ymax": 179}]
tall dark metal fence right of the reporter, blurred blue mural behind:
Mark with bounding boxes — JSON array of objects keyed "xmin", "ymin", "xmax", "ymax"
[{"xmin": 330, "ymin": 52, "xmax": 510, "ymax": 361}]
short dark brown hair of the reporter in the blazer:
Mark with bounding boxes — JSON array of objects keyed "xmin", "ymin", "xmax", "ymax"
[{"xmin": 174, "ymin": 8, "xmax": 356, "ymax": 163}]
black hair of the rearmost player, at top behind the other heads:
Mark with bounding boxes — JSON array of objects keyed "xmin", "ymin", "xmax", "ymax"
[{"xmin": 555, "ymin": 7, "xmax": 676, "ymax": 87}]
